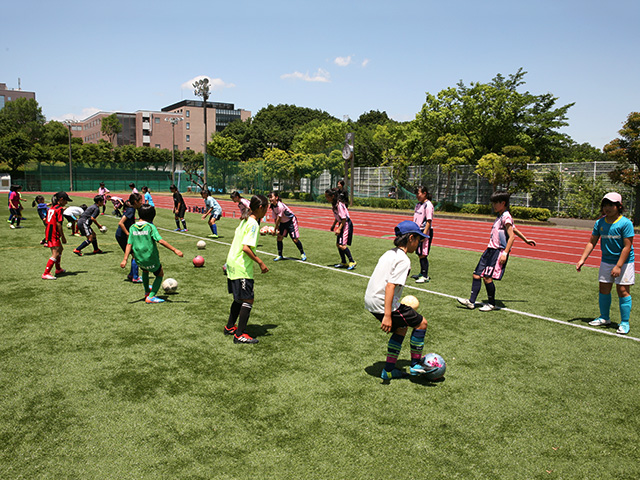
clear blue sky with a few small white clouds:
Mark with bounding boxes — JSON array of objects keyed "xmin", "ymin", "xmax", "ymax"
[{"xmin": 0, "ymin": 0, "xmax": 640, "ymax": 148}]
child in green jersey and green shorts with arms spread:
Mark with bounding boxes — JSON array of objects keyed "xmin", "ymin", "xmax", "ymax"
[{"xmin": 120, "ymin": 205, "xmax": 183, "ymax": 303}]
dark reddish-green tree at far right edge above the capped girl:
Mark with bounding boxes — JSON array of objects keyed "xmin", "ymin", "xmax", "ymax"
[{"xmin": 604, "ymin": 112, "xmax": 640, "ymax": 225}]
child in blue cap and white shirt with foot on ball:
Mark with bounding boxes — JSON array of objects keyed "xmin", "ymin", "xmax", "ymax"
[{"xmin": 364, "ymin": 220, "xmax": 427, "ymax": 380}]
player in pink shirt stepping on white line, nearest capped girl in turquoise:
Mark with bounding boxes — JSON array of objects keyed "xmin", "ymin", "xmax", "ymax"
[{"xmin": 457, "ymin": 192, "xmax": 536, "ymax": 312}]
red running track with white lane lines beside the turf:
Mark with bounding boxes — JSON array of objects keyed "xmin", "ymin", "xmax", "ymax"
[{"xmin": 55, "ymin": 192, "xmax": 624, "ymax": 269}]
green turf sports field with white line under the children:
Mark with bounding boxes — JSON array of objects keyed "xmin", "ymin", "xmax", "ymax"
[{"xmin": 0, "ymin": 207, "xmax": 640, "ymax": 479}]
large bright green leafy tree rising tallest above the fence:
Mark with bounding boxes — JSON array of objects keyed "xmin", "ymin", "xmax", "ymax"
[{"xmin": 416, "ymin": 69, "xmax": 573, "ymax": 164}]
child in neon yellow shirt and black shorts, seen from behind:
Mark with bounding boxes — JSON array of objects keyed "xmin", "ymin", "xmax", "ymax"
[{"xmin": 224, "ymin": 195, "xmax": 269, "ymax": 344}]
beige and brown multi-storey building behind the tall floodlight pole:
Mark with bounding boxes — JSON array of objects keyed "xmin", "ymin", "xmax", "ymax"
[{"xmin": 71, "ymin": 100, "xmax": 251, "ymax": 152}]
